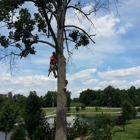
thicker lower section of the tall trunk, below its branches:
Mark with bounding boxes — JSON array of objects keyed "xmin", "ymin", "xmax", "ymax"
[{"xmin": 55, "ymin": 54, "xmax": 67, "ymax": 140}]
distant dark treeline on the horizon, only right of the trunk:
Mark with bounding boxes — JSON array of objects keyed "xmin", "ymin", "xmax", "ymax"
[{"xmin": 73, "ymin": 86, "xmax": 140, "ymax": 107}]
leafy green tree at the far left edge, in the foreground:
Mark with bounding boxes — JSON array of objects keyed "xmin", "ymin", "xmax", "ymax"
[{"xmin": 0, "ymin": 100, "xmax": 16, "ymax": 140}]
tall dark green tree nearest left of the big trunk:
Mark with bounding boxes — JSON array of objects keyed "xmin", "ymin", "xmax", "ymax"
[{"xmin": 24, "ymin": 91, "xmax": 46, "ymax": 140}]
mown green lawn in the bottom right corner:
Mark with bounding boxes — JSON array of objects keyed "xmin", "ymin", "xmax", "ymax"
[{"xmin": 112, "ymin": 119, "xmax": 140, "ymax": 140}]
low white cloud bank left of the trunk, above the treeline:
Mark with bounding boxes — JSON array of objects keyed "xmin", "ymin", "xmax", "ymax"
[{"xmin": 0, "ymin": 73, "xmax": 56, "ymax": 95}]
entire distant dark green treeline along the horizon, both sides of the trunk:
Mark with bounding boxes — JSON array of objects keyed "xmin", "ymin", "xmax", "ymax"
[{"xmin": 0, "ymin": 86, "xmax": 140, "ymax": 107}]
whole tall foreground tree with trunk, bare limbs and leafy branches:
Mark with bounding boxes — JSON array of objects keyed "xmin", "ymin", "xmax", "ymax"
[{"xmin": 0, "ymin": 0, "xmax": 119, "ymax": 140}]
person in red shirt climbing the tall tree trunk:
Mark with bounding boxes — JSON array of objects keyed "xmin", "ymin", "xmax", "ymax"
[{"xmin": 48, "ymin": 52, "xmax": 57, "ymax": 78}]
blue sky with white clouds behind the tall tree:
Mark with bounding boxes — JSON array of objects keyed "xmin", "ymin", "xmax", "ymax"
[{"xmin": 0, "ymin": 0, "xmax": 140, "ymax": 98}]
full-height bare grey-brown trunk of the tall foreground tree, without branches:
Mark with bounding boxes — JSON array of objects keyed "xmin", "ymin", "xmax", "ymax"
[{"xmin": 55, "ymin": 0, "xmax": 67, "ymax": 140}]
